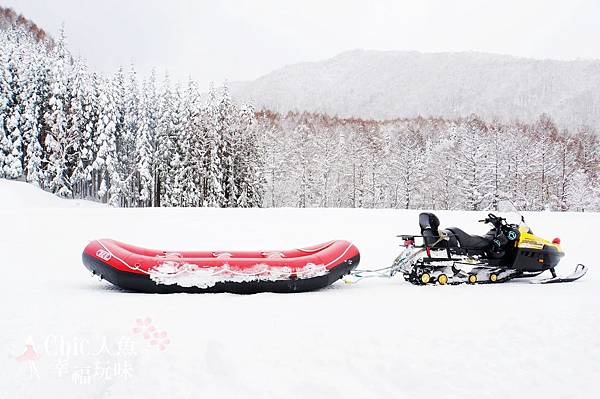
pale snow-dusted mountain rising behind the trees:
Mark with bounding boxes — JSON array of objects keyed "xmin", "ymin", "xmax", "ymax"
[{"xmin": 231, "ymin": 50, "xmax": 600, "ymax": 128}]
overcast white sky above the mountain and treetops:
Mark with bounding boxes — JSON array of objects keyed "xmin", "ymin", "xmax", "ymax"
[{"xmin": 0, "ymin": 0, "xmax": 600, "ymax": 84}]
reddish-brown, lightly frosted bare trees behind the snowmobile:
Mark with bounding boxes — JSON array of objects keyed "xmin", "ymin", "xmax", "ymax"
[{"xmin": 258, "ymin": 111, "xmax": 600, "ymax": 211}]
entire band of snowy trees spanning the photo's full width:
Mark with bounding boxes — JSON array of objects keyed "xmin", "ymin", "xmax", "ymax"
[{"xmin": 0, "ymin": 26, "xmax": 600, "ymax": 211}]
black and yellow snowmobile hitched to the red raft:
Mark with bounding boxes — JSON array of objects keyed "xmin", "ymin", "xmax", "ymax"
[{"xmin": 389, "ymin": 205, "xmax": 587, "ymax": 285}]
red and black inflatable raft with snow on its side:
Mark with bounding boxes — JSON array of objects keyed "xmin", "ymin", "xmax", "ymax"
[{"xmin": 82, "ymin": 239, "xmax": 360, "ymax": 293}]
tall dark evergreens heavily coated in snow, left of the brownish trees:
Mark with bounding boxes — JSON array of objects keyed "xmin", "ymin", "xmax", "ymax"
[{"xmin": 0, "ymin": 29, "xmax": 262, "ymax": 207}]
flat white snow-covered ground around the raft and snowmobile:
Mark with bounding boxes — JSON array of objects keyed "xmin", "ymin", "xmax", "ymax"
[{"xmin": 0, "ymin": 180, "xmax": 600, "ymax": 399}]
